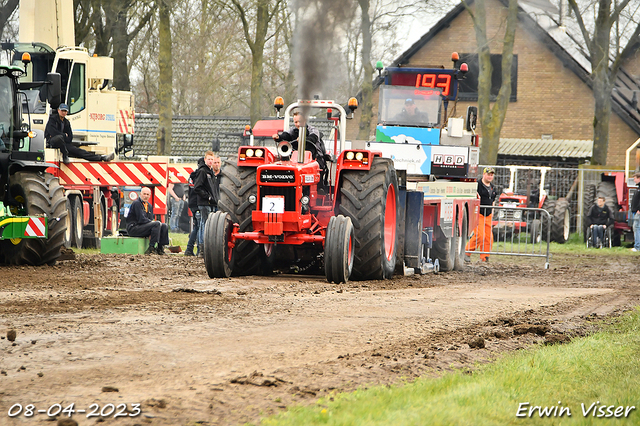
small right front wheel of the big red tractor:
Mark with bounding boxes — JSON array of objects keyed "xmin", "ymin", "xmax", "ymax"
[{"xmin": 324, "ymin": 215, "xmax": 354, "ymax": 284}]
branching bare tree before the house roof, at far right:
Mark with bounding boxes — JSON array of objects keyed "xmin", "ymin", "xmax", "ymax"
[{"xmin": 569, "ymin": 0, "xmax": 640, "ymax": 165}]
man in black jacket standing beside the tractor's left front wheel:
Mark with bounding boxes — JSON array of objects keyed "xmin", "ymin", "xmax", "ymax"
[{"xmin": 193, "ymin": 151, "xmax": 221, "ymax": 257}]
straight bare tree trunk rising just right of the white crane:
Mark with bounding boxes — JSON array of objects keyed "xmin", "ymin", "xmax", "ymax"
[{"xmin": 157, "ymin": 0, "xmax": 173, "ymax": 155}]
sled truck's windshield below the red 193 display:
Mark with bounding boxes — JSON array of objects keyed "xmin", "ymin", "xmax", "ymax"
[{"xmin": 378, "ymin": 86, "xmax": 441, "ymax": 127}]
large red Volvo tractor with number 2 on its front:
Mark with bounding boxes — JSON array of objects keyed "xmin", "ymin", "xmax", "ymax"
[{"xmin": 204, "ymin": 98, "xmax": 400, "ymax": 283}]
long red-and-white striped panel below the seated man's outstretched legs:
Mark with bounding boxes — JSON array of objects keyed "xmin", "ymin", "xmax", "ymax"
[{"xmin": 57, "ymin": 161, "xmax": 168, "ymax": 186}]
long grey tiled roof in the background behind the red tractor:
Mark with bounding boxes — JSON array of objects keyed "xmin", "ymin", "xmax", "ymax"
[{"xmin": 134, "ymin": 114, "xmax": 338, "ymax": 163}]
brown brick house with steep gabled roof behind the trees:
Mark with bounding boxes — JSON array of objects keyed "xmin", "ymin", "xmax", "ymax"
[{"xmin": 347, "ymin": 0, "xmax": 640, "ymax": 167}]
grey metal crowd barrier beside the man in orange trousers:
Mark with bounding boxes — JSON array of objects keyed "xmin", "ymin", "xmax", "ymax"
[{"xmin": 467, "ymin": 206, "xmax": 551, "ymax": 269}]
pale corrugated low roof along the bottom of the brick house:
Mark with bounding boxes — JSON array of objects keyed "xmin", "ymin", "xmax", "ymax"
[{"xmin": 498, "ymin": 138, "xmax": 593, "ymax": 158}]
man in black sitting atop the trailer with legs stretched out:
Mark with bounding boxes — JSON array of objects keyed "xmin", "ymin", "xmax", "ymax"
[{"xmin": 44, "ymin": 104, "xmax": 115, "ymax": 164}]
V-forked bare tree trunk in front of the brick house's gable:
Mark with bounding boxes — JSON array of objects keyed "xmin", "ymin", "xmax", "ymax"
[{"xmin": 463, "ymin": 0, "xmax": 518, "ymax": 164}]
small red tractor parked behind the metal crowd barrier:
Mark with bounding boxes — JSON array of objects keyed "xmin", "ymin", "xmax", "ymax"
[{"xmin": 492, "ymin": 166, "xmax": 571, "ymax": 244}]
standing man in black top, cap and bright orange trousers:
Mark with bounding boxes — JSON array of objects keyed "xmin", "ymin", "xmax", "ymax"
[{"xmin": 465, "ymin": 167, "xmax": 496, "ymax": 262}]
